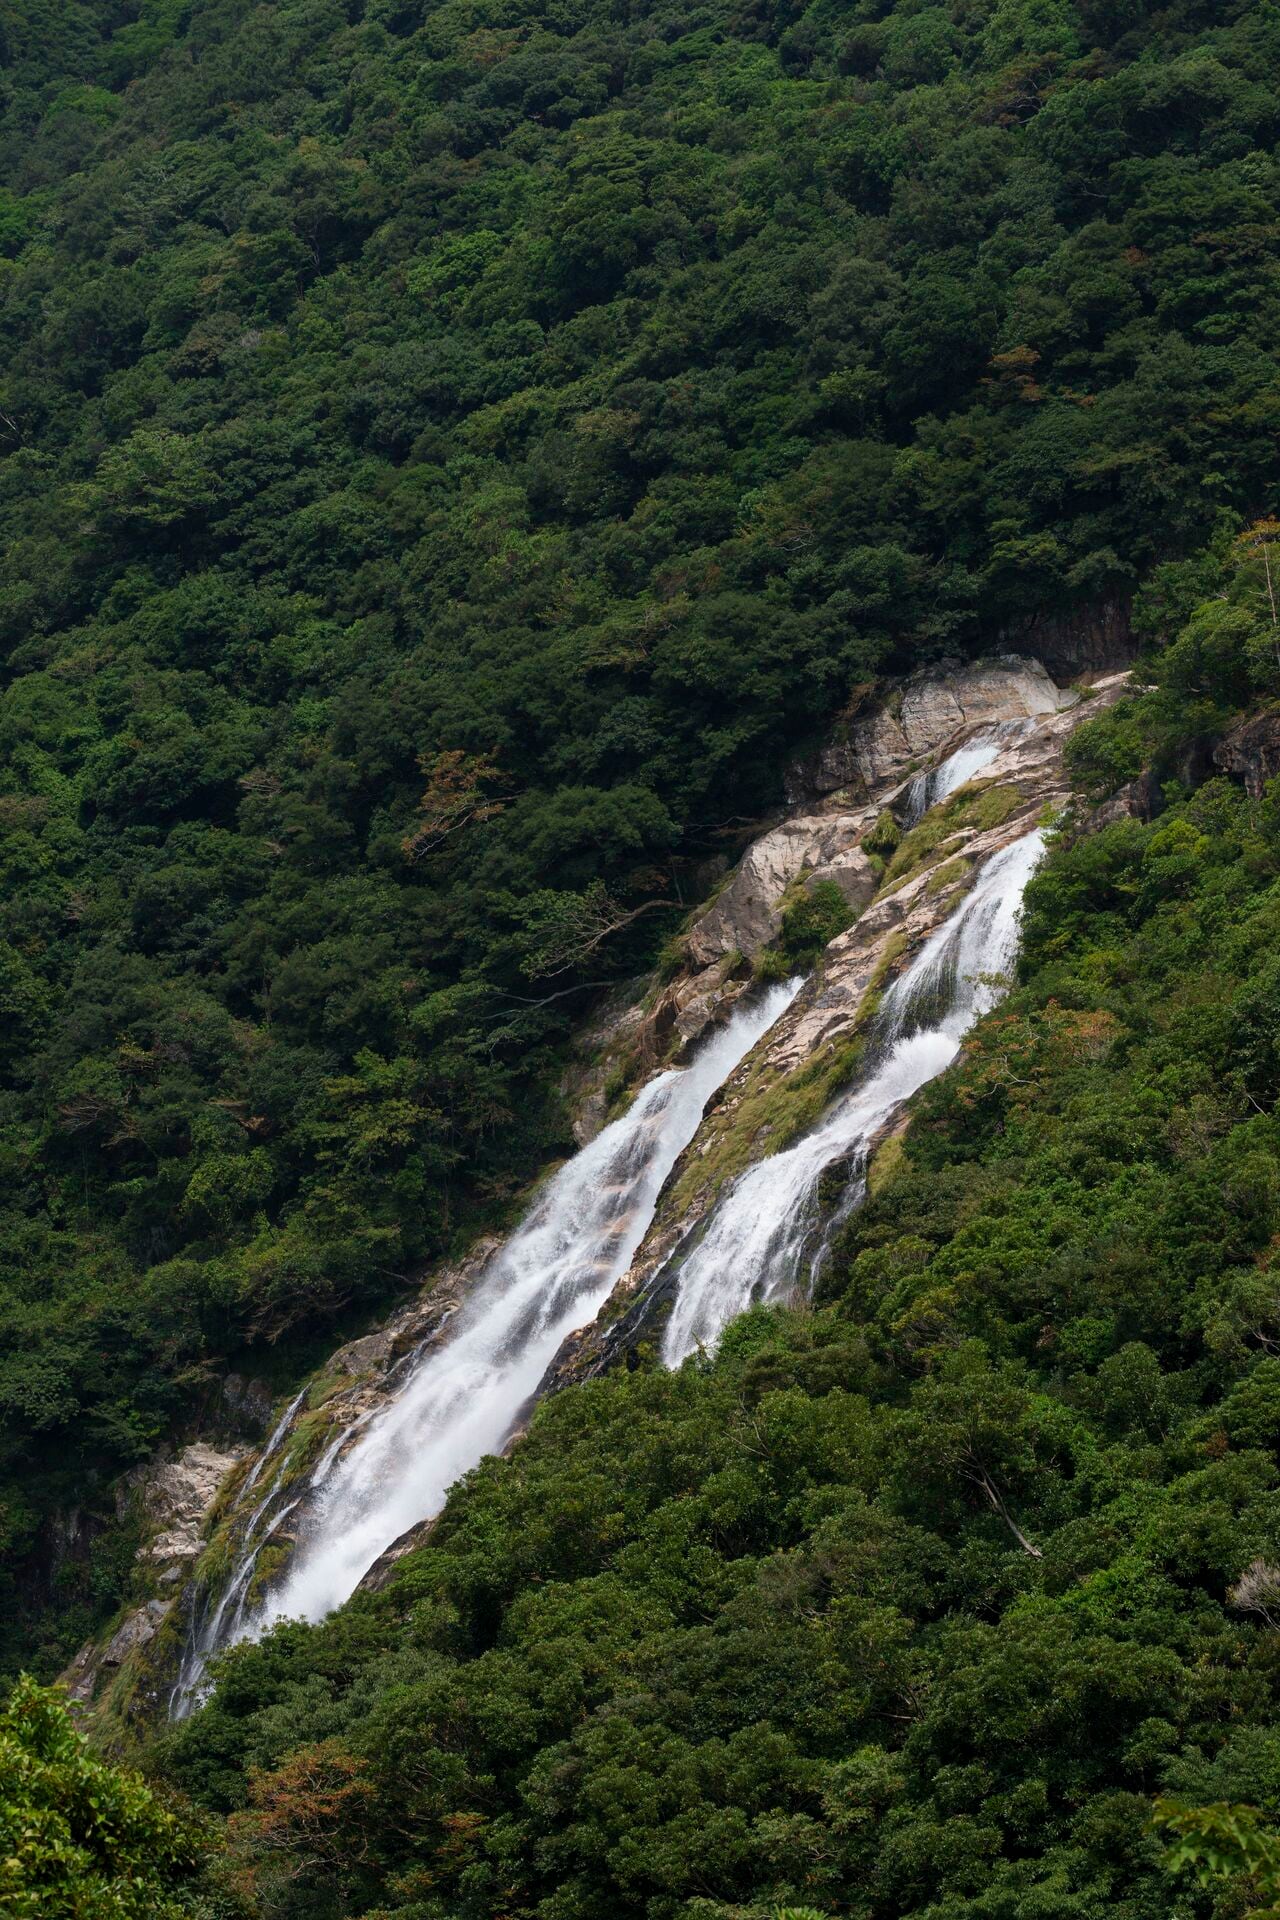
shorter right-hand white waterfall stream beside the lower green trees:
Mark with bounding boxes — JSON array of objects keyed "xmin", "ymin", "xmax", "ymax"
[{"xmin": 662, "ymin": 829, "xmax": 1044, "ymax": 1367}]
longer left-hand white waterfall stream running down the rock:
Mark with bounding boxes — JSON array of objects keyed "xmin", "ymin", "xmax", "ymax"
[{"xmin": 171, "ymin": 979, "xmax": 800, "ymax": 1718}]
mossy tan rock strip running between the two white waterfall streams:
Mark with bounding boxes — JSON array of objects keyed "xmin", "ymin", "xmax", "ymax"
[{"xmin": 547, "ymin": 660, "xmax": 1128, "ymax": 1390}]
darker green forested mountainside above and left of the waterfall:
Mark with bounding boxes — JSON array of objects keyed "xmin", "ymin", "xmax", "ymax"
[{"xmin": 0, "ymin": 0, "xmax": 1280, "ymax": 1667}]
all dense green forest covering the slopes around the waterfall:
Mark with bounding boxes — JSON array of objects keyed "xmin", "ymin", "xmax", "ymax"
[{"xmin": 10, "ymin": 0, "xmax": 1280, "ymax": 1920}]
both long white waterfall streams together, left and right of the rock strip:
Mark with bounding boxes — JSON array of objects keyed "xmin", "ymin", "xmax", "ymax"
[{"xmin": 171, "ymin": 817, "xmax": 1044, "ymax": 1718}]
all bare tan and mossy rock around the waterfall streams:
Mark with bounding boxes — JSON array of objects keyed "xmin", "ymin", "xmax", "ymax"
[{"xmin": 69, "ymin": 655, "xmax": 1125, "ymax": 1699}]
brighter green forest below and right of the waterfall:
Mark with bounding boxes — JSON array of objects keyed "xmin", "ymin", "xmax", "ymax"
[{"xmin": 130, "ymin": 557, "xmax": 1280, "ymax": 1920}]
